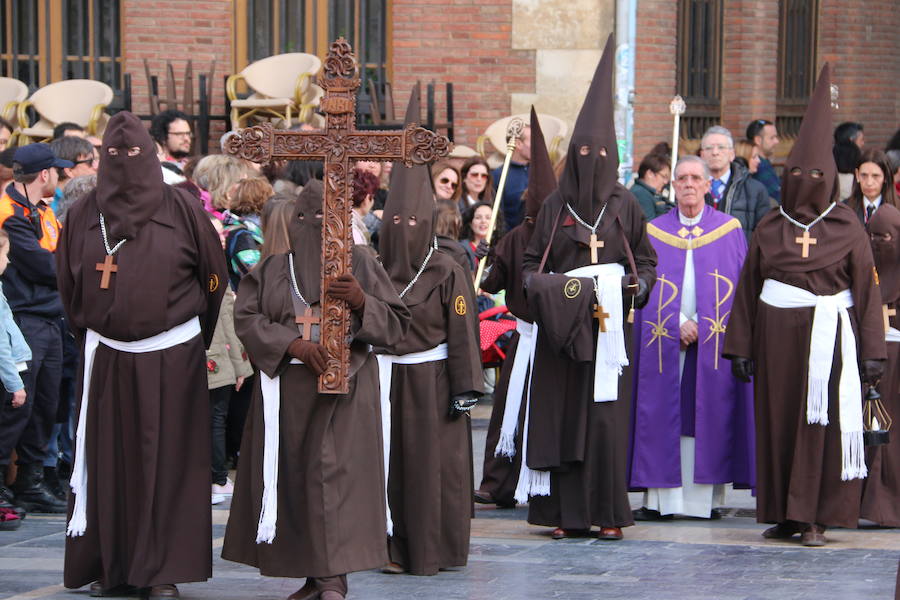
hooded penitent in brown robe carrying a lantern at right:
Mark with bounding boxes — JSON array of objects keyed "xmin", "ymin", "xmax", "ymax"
[{"xmin": 723, "ymin": 65, "xmax": 885, "ymax": 545}]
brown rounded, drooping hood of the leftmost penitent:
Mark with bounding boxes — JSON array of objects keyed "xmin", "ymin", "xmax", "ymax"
[{"xmin": 97, "ymin": 111, "xmax": 165, "ymax": 239}]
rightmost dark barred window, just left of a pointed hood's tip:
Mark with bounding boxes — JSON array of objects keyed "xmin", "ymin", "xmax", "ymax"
[{"xmin": 775, "ymin": 0, "xmax": 818, "ymax": 137}]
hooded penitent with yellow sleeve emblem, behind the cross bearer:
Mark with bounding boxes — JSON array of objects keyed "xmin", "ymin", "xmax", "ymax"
[{"xmin": 375, "ymin": 90, "xmax": 482, "ymax": 575}]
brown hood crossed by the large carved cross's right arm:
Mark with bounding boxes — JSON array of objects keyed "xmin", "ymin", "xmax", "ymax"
[{"xmin": 378, "ymin": 83, "xmax": 450, "ymax": 304}]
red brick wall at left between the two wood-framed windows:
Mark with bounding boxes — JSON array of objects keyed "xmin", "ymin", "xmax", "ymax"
[{"xmin": 122, "ymin": 0, "xmax": 234, "ymax": 146}]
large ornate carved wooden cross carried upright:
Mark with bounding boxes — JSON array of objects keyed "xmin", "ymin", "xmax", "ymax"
[{"xmin": 225, "ymin": 38, "xmax": 450, "ymax": 394}]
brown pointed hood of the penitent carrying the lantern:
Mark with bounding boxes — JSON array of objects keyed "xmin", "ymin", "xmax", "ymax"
[{"xmin": 781, "ymin": 63, "xmax": 837, "ymax": 222}]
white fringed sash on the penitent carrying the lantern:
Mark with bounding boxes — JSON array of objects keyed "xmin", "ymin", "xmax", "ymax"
[{"xmin": 760, "ymin": 279, "xmax": 867, "ymax": 481}]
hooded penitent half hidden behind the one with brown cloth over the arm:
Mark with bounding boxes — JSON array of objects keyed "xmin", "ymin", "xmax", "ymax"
[{"xmin": 475, "ymin": 107, "xmax": 556, "ymax": 506}]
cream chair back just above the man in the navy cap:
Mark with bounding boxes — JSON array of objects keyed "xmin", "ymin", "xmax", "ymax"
[{"xmin": 29, "ymin": 79, "xmax": 113, "ymax": 127}]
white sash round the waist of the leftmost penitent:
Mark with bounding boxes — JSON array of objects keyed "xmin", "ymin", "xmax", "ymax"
[{"xmin": 66, "ymin": 317, "xmax": 201, "ymax": 537}]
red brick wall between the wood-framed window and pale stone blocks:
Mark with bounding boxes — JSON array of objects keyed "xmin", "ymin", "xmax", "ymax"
[{"xmin": 392, "ymin": 0, "xmax": 535, "ymax": 148}]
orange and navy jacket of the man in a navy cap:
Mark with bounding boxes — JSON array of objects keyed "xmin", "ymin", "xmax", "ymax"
[{"xmin": 0, "ymin": 183, "xmax": 63, "ymax": 319}]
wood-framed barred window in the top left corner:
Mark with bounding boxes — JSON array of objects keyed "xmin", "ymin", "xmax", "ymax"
[{"xmin": 0, "ymin": 0, "xmax": 122, "ymax": 90}]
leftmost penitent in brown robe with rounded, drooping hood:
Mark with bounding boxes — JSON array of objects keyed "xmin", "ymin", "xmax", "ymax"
[{"xmin": 57, "ymin": 112, "xmax": 228, "ymax": 588}]
